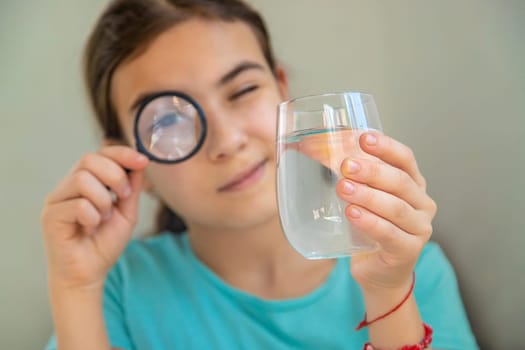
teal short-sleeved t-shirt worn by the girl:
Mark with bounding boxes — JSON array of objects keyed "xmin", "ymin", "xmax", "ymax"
[{"xmin": 47, "ymin": 233, "xmax": 478, "ymax": 350}]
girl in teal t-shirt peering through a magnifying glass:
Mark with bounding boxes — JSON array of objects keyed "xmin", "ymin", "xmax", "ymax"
[{"xmin": 42, "ymin": 0, "xmax": 477, "ymax": 350}]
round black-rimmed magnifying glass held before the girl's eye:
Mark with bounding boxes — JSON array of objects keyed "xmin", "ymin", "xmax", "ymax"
[{"xmin": 133, "ymin": 91, "xmax": 207, "ymax": 164}]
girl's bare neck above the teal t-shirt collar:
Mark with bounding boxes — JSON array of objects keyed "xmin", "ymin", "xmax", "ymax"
[{"xmin": 188, "ymin": 216, "xmax": 333, "ymax": 299}]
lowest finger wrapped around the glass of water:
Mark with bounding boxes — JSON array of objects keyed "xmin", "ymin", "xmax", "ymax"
[{"xmin": 345, "ymin": 205, "xmax": 426, "ymax": 258}]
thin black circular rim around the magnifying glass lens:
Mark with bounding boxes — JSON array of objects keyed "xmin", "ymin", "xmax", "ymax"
[{"xmin": 133, "ymin": 90, "xmax": 208, "ymax": 164}]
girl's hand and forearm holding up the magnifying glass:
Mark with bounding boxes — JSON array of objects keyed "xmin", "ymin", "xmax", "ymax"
[{"xmin": 41, "ymin": 146, "xmax": 147, "ymax": 350}]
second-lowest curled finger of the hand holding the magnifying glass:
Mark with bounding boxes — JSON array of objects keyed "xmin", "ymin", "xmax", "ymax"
[{"xmin": 45, "ymin": 169, "xmax": 113, "ymax": 217}]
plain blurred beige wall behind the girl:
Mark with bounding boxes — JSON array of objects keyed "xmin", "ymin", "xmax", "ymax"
[{"xmin": 0, "ymin": 0, "xmax": 525, "ymax": 349}]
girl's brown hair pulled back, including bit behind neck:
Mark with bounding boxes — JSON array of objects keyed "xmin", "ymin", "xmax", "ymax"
[{"xmin": 84, "ymin": 0, "xmax": 276, "ymax": 233}]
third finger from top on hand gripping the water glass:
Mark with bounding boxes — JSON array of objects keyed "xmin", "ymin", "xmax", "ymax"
[{"xmin": 336, "ymin": 180, "xmax": 432, "ymax": 237}]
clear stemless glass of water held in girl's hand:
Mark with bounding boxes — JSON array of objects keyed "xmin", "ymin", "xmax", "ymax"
[{"xmin": 277, "ymin": 92, "xmax": 381, "ymax": 259}]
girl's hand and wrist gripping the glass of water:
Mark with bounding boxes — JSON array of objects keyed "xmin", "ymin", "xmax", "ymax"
[{"xmin": 337, "ymin": 133, "xmax": 436, "ymax": 349}]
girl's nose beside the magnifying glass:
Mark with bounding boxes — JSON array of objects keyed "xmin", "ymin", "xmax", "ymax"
[{"xmin": 206, "ymin": 106, "xmax": 248, "ymax": 161}]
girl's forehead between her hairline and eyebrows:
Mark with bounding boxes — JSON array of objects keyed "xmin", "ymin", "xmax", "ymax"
[{"xmin": 111, "ymin": 19, "xmax": 267, "ymax": 114}]
